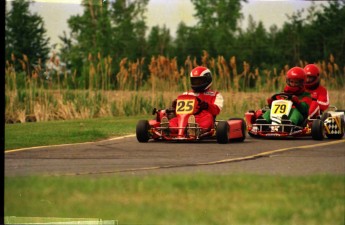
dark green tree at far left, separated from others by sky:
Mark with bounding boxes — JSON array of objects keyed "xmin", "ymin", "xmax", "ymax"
[{"xmin": 5, "ymin": 0, "xmax": 50, "ymax": 72}]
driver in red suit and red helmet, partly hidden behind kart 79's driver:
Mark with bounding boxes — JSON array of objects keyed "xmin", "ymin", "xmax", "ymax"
[{"xmin": 304, "ymin": 64, "xmax": 329, "ymax": 118}]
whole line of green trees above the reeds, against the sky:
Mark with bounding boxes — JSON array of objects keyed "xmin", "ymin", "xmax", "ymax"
[{"xmin": 5, "ymin": 0, "xmax": 345, "ymax": 88}]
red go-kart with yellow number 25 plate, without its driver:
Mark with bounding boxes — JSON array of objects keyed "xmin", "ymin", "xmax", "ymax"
[{"xmin": 136, "ymin": 95, "xmax": 246, "ymax": 144}]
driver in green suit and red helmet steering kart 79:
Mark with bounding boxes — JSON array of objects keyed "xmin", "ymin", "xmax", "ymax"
[{"xmin": 262, "ymin": 67, "xmax": 312, "ymax": 126}]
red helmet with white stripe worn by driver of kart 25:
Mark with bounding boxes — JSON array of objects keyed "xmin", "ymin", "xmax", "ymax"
[{"xmin": 190, "ymin": 66, "xmax": 212, "ymax": 92}]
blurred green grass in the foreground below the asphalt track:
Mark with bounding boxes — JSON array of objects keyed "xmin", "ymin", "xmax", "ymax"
[{"xmin": 4, "ymin": 174, "xmax": 345, "ymax": 225}]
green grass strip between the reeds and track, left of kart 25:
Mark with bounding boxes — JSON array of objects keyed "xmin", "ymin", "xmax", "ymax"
[{"xmin": 5, "ymin": 116, "xmax": 141, "ymax": 150}]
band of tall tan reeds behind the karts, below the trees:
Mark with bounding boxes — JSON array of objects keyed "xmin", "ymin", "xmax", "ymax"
[{"xmin": 5, "ymin": 51, "xmax": 345, "ymax": 123}]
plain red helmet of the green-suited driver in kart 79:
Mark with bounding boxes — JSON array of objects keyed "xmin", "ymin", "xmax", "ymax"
[{"xmin": 284, "ymin": 67, "xmax": 306, "ymax": 94}]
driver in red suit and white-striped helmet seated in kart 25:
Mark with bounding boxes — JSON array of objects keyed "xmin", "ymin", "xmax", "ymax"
[{"xmin": 161, "ymin": 66, "xmax": 224, "ymax": 135}]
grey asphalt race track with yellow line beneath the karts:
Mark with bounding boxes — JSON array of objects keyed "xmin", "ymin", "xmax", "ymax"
[{"xmin": 5, "ymin": 135, "xmax": 345, "ymax": 176}]
